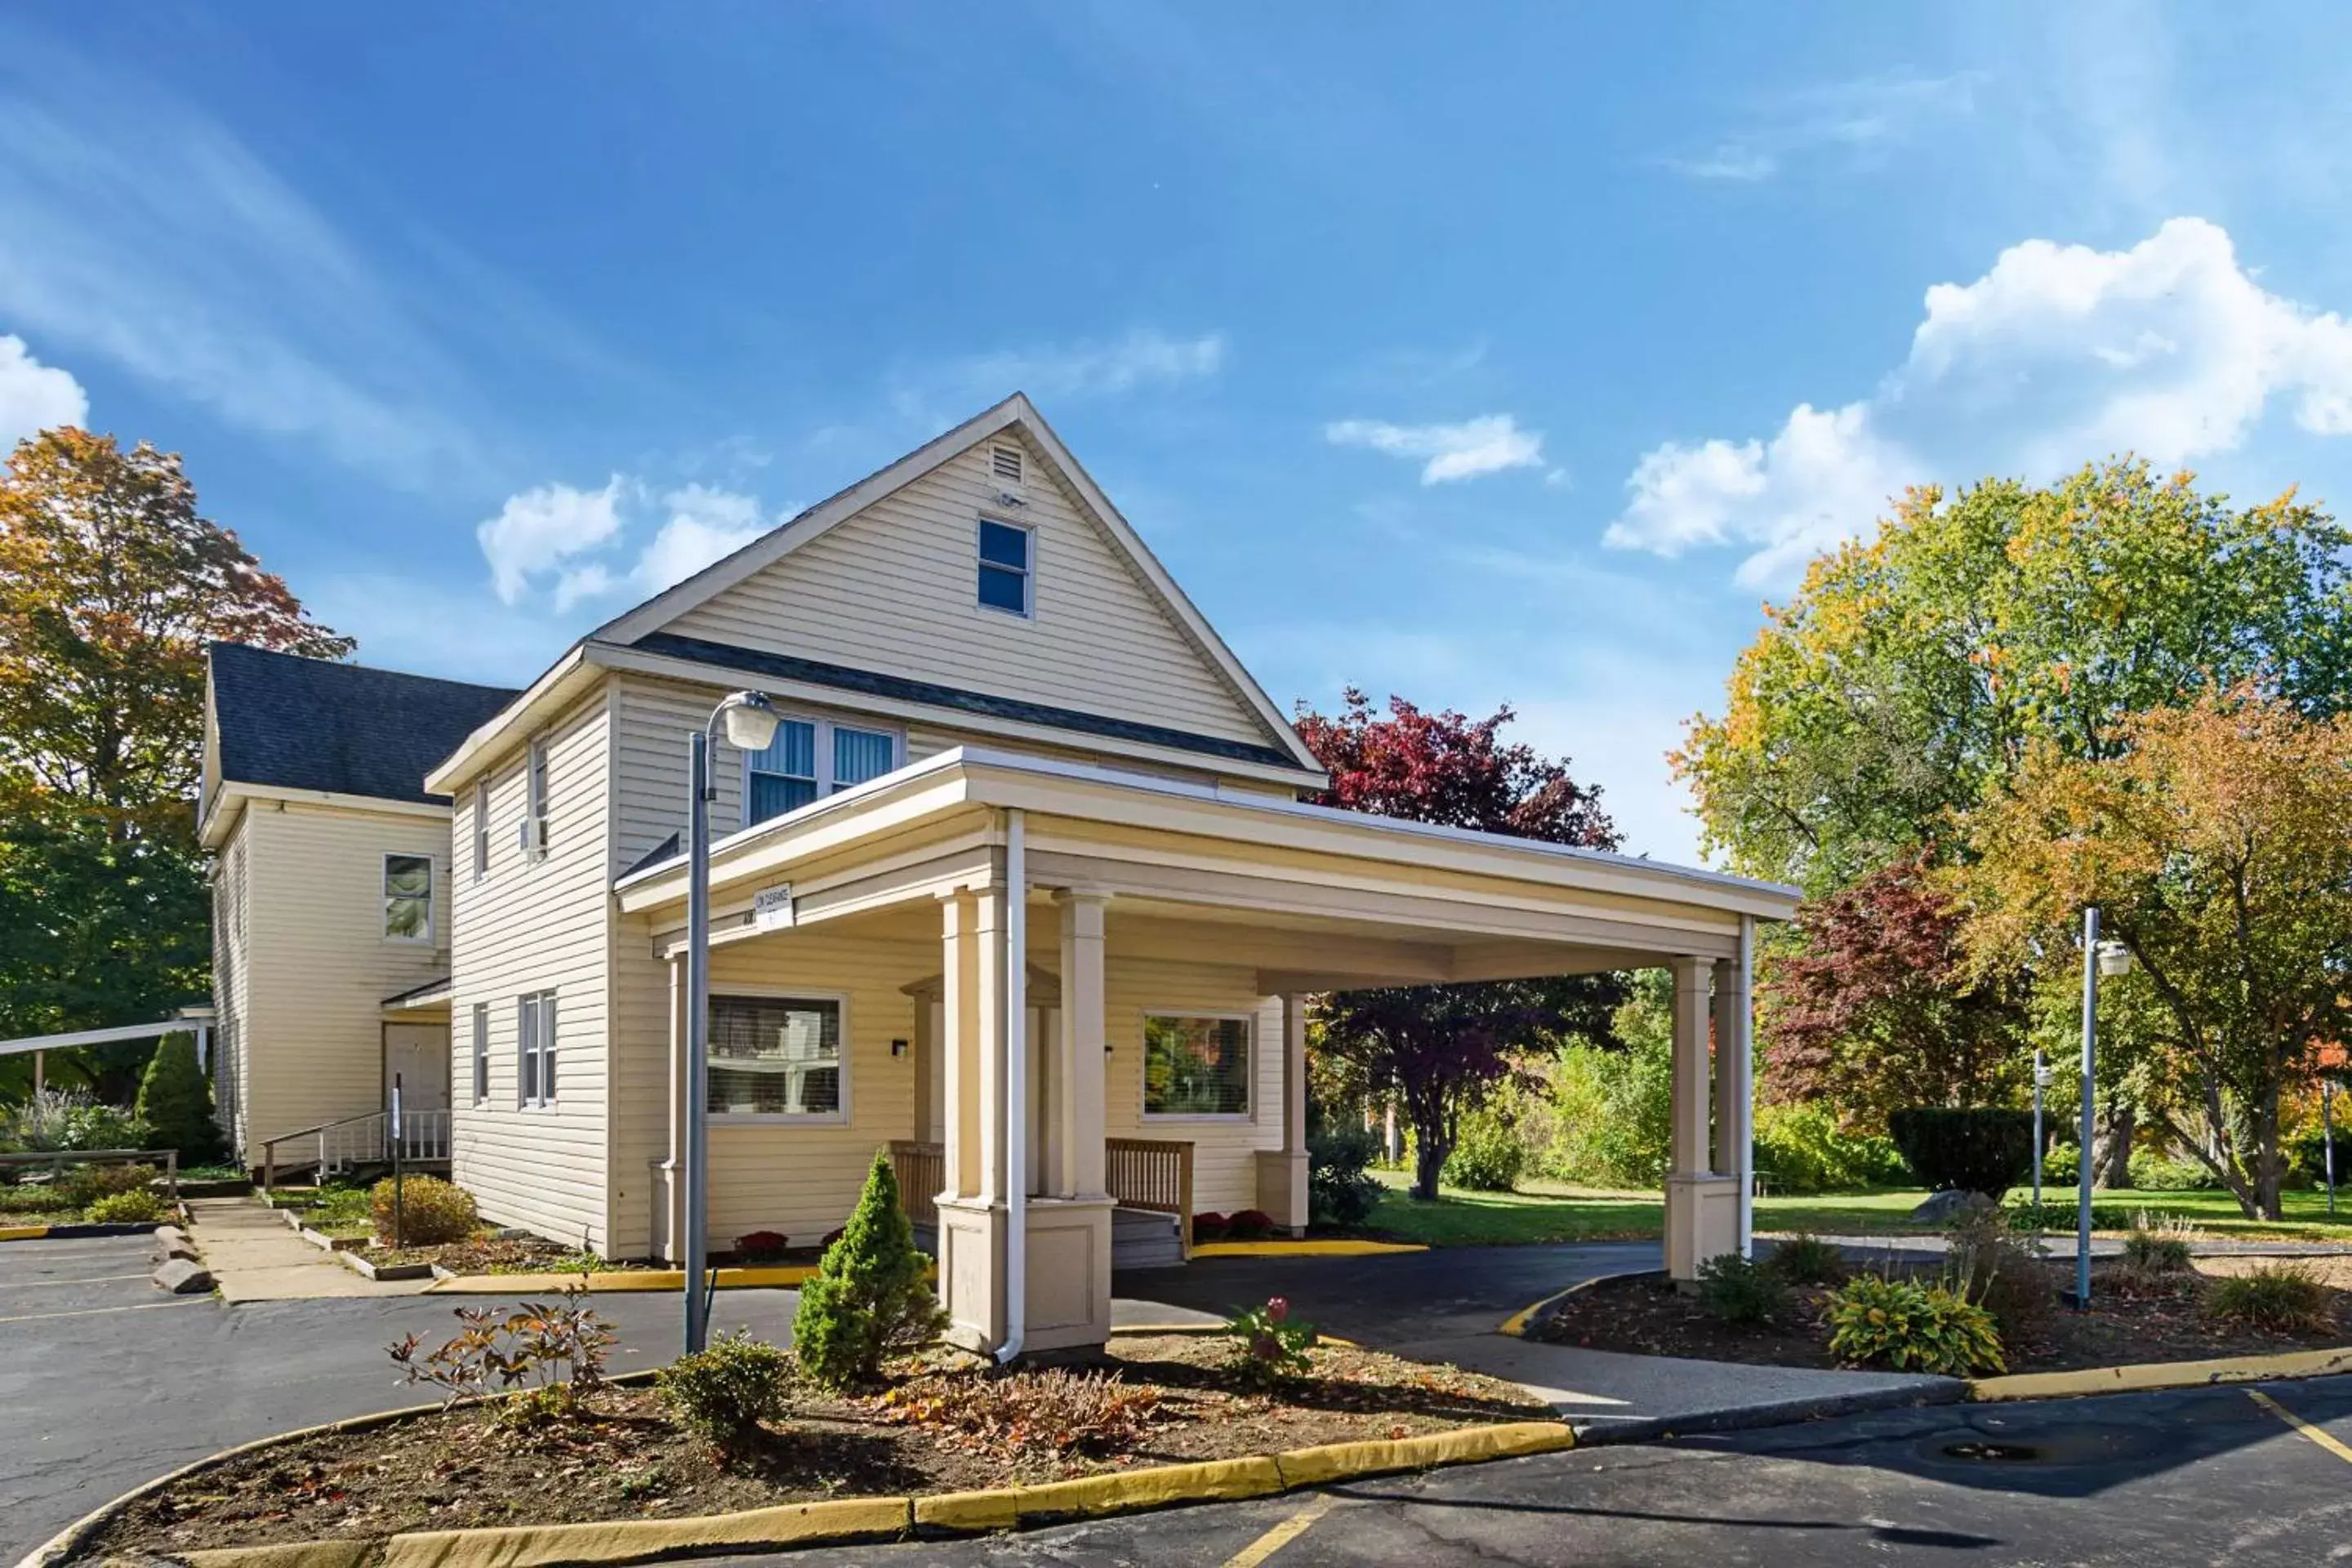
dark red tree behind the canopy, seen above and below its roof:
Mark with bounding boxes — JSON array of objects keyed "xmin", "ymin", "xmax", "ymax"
[{"xmin": 1298, "ymin": 688, "xmax": 1625, "ymax": 1199}]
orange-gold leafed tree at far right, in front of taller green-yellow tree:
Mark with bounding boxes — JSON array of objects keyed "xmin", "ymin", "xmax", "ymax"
[{"xmin": 1948, "ymin": 687, "xmax": 2352, "ymax": 1220}]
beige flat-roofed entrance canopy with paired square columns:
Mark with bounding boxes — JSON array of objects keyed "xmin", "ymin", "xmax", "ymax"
[{"xmin": 617, "ymin": 747, "xmax": 1797, "ymax": 1349}]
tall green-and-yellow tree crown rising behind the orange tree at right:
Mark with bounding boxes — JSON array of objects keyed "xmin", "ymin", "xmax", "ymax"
[{"xmin": 1675, "ymin": 461, "xmax": 2352, "ymax": 893}]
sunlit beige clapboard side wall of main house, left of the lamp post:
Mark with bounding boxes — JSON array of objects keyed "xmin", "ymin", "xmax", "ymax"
[{"xmin": 449, "ymin": 691, "xmax": 612, "ymax": 1250}]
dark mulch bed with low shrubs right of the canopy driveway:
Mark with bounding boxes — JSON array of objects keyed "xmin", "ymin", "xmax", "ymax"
[{"xmin": 1529, "ymin": 1263, "xmax": 2352, "ymax": 1373}]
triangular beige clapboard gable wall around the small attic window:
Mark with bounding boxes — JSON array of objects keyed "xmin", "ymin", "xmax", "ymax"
[{"xmin": 663, "ymin": 444, "xmax": 1270, "ymax": 746}]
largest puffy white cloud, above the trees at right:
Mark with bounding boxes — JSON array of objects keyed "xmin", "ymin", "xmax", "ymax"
[{"xmin": 1604, "ymin": 219, "xmax": 2352, "ymax": 586}]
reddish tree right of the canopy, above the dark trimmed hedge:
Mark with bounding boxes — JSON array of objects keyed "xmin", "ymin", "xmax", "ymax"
[{"xmin": 1757, "ymin": 858, "xmax": 2029, "ymax": 1131}]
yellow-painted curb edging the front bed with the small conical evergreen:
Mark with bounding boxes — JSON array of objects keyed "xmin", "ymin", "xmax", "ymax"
[{"xmin": 16, "ymin": 1401, "xmax": 1578, "ymax": 1568}]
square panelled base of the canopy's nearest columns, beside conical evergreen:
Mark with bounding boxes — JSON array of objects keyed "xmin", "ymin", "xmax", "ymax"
[{"xmin": 938, "ymin": 1196, "xmax": 1115, "ymax": 1356}]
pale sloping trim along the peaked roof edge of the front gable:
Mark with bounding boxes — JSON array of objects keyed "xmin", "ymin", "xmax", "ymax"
[{"xmin": 588, "ymin": 393, "xmax": 1322, "ymax": 776}]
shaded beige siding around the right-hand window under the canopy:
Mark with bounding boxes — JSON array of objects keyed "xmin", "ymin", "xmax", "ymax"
[{"xmin": 1103, "ymin": 959, "xmax": 1282, "ymax": 1213}]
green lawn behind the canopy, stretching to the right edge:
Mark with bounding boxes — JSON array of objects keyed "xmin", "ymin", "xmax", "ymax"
[{"xmin": 1371, "ymin": 1171, "xmax": 2352, "ymax": 1246}]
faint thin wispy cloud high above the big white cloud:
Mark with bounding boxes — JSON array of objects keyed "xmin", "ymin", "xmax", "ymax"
[{"xmin": 1658, "ymin": 68, "xmax": 1978, "ymax": 184}]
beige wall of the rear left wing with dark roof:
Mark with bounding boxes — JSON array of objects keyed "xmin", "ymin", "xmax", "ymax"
[{"xmin": 230, "ymin": 802, "xmax": 452, "ymax": 1161}]
